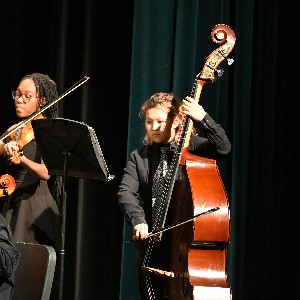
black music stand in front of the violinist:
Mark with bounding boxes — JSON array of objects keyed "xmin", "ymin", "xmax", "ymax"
[{"xmin": 31, "ymin": 118, "xmax": 114, "ymax": 300}]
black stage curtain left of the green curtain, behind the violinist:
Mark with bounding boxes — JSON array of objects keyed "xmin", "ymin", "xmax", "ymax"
[{"xmin": 0, "ymin": 0, "xmax": 133, "ymax": 299}]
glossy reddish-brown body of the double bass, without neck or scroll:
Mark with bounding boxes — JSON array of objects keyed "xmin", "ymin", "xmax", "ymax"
[{"xmin": 165, "ymin": 150, "xmax": 231, "ymax": 300}]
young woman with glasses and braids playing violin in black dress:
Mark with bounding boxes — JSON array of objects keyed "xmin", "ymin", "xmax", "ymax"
[{"xmin": 0, "ymin": 73, "xmax": 60, "ymax": 250}]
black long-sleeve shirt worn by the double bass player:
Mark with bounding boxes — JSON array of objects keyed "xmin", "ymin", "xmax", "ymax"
[{"xmin": 118, "ymin": 114, "xmax": 231, "ymax": 226}]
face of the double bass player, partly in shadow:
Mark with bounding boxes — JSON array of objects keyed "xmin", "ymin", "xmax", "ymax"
[{"xmin": 145, "ymin": 107, "xmax": 178, "ymax": 144}]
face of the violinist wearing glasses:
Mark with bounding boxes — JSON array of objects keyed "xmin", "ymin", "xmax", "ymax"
[{"xmin": 15, "ymin": 79, "xmax": 39, "ymax": 118}]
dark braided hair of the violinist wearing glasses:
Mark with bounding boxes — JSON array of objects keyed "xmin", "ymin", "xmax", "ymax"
[{"xmin": 21, "ymin": 73, "xmax": 59, "ymax": 118}]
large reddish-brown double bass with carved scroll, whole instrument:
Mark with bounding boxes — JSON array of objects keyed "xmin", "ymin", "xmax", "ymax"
[{"xmin": 143, "ymin": 24, "xmax": 236, "ymax": 300}]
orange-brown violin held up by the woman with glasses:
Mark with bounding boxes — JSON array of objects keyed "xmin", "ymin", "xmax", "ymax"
[{"xmin": 10, "ymin": 113, "xmax": 44, "ymax": 165}]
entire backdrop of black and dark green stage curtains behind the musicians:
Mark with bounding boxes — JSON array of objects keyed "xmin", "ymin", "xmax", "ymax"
[{"xmin": 0, "ymin": 0, "xmax": 300, "ymax": 300}]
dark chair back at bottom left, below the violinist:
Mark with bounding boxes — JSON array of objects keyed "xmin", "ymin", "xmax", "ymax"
[{"xmin": 11, "ymin": 243, "xmax": 56, "ymax": 300}]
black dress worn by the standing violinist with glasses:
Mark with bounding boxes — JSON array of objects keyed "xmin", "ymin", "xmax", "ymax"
[{"xmin": 3, "ymin": 140, "xmax": 61, "ymax": 250}]
